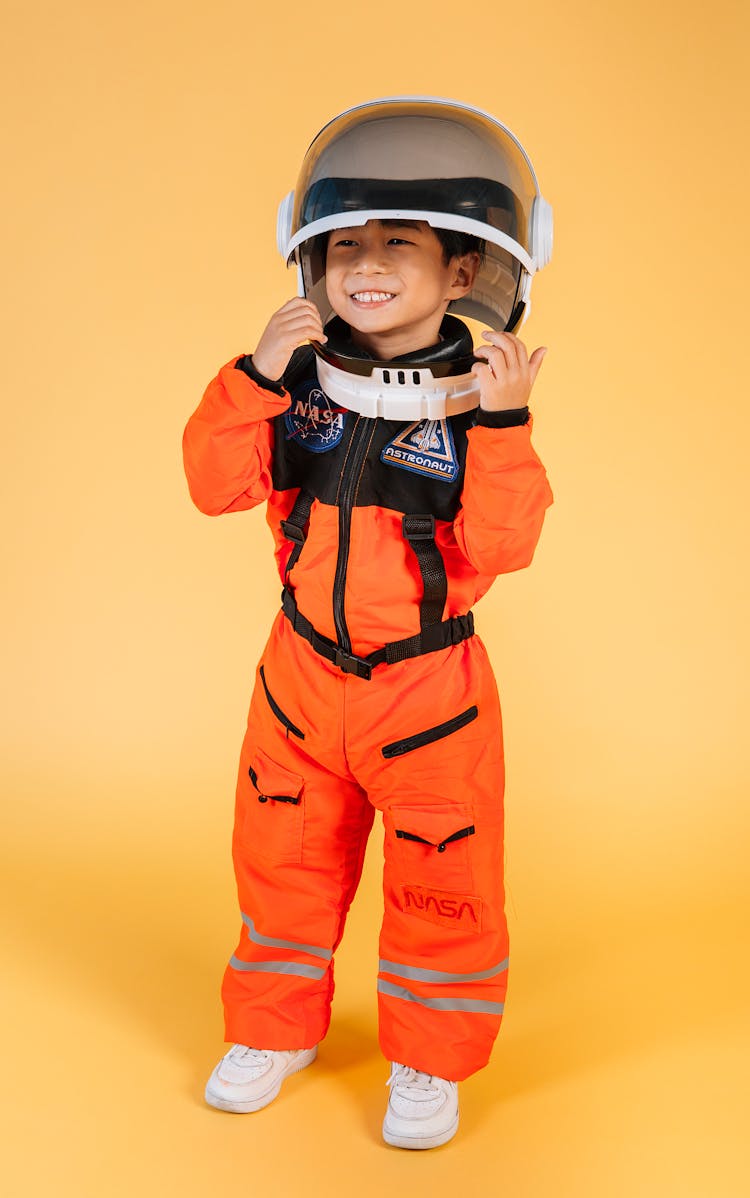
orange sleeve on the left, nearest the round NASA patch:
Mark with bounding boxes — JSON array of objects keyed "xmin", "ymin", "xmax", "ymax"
[{"xmin": 182, "ymin": 357, "xmax": 289, "ymax": 516}]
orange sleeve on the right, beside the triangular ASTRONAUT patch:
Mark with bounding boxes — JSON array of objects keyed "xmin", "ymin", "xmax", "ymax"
[{"xmin": 454, "ymin": 423, "xmax": 552, "ymax": 575}]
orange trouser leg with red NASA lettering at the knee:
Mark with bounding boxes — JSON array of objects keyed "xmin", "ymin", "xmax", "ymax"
[{"xmin": 345, "ymin": 641, "xmax": 508, "ymax": 1081}]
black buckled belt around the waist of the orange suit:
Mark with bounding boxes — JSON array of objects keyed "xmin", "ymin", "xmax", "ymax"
[{"xmin": 282, "ymin": 588, "xmax": 474, "ymax": 679}]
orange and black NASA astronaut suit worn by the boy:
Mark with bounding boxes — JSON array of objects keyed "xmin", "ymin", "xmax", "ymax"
[{"xmin": 185, "ymin": 316, "xmax": 551, "ymax": 1081}]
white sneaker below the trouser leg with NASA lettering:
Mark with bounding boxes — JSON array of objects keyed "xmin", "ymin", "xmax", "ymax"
[{"xmin": 383, "ymin": 1061, "xmax": 459, "ymax": 1148}]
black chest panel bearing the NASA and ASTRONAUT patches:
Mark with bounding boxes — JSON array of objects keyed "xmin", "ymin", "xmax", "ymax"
[{"xmin": 273, "ymin": 364, "xmax": 476, "ymax": 520}]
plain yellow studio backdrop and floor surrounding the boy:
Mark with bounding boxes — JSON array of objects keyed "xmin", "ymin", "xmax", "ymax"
[{"xmin": 0, "ymin": 0, "xmax": 750, "ymax": 1198}]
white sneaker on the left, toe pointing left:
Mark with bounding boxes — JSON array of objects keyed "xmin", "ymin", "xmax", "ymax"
[{"xmin": 201, "ymin": 1045, "xmax": 317, "ymax": 1114}]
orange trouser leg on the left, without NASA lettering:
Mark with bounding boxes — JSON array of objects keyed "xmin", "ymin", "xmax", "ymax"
[{"xmin": 222, "ymin": 618, "xmax": 373, "ymax": 1049}]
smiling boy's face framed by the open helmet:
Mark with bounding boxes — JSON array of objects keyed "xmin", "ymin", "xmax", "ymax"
[{"xmin": 326, "ymin": 220, "xmax": 477, "ymax": 359}]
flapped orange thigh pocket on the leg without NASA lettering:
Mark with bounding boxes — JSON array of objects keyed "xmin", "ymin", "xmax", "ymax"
[{"xmin": 240, "ymin": 749, "xmax": 304, "ymax": 864}]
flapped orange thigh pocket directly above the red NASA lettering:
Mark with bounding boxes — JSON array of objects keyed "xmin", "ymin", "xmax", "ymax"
[{"xmin": 385, "ymin": 799, "xmax": 477, "ymax": 894}]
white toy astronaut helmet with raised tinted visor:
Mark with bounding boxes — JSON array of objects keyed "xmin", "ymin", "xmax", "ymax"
[{"xmin": 277, "ymin": 96, "xmax": 552, "ymax": 420}]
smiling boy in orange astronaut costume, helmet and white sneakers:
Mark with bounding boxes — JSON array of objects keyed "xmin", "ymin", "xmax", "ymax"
[{"xmin": 185, "ymin": 98, "xmax": 551, "ymax": 1149}]
